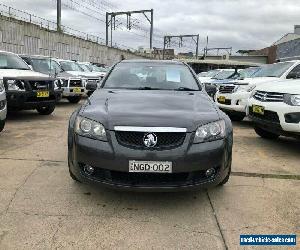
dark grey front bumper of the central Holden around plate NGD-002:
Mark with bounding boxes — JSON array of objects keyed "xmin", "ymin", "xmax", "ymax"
[{"xmin": 69, "ymin": 133, "xmax": 231, "ymax": 191}]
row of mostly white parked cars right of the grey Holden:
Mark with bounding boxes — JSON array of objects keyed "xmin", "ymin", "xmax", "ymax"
[{"xmin": 198, "ymin": 60, "xmax": 300, "ymax": 139}]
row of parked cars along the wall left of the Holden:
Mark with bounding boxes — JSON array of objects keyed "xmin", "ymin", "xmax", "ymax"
[{"xmin": 0, "ymin": 51, "xmax": 107, "ymax": 132}]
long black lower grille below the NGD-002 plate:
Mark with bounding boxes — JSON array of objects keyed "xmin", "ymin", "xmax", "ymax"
[{"xmin": 79, "ymin": 163, "xmax": 219, "ymax": 187}]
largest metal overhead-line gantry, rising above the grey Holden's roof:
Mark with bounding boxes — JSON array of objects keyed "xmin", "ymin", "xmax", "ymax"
[{"xmin": 105, "ymin": 9, "xmax": 153, "ymax": 49}]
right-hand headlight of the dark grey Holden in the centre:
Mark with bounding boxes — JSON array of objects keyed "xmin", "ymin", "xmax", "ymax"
[{"xmin": 194, "ymin": 120, "xmax": 225, "ymax": 143}]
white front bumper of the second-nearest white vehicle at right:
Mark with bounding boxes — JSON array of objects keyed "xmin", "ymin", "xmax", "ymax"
[{"xmin": 216, "ymin": 91, "xmax": 251, "ymax": 113}]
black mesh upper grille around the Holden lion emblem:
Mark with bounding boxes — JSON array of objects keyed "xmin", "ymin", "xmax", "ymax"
[{"xmin": 115, "ymin": 131, "xmax": 185, "ymax": 150}]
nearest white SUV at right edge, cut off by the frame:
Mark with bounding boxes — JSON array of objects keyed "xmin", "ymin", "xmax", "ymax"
[{"xmin": 247, "ymin": 79, "xmax": 300, "ymax": 139}]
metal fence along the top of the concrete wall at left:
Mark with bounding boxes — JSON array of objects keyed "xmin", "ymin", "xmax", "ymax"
[{"xmin": 0, "ymin": 4, "xmax": 129, "ymax": 50}]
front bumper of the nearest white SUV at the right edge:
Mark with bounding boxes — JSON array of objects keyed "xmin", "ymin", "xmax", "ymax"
[{"xmin": 247, "ymin": 98, "xmax": 300, "ymax": 136}]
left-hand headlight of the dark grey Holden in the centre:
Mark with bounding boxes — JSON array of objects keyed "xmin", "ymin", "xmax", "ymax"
[{"xmin": 75, "ymin": 116, "xmax": 107, "ymax": 141}]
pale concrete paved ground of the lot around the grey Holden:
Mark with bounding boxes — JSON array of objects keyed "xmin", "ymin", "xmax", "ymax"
[{"xmin": 0, "ymin": 99, "xmax": 300, "ymax": 249}]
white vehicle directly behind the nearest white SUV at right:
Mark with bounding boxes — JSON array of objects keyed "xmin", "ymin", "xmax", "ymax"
[{"xmin": 216, "ymin": 60, "xmax": 300, "ymax": 121}]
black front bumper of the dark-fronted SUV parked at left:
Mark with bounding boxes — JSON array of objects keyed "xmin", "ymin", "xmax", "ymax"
[{"xmin": 6, "ymin": 90, "xmax": 57, "ymax": 110}]
